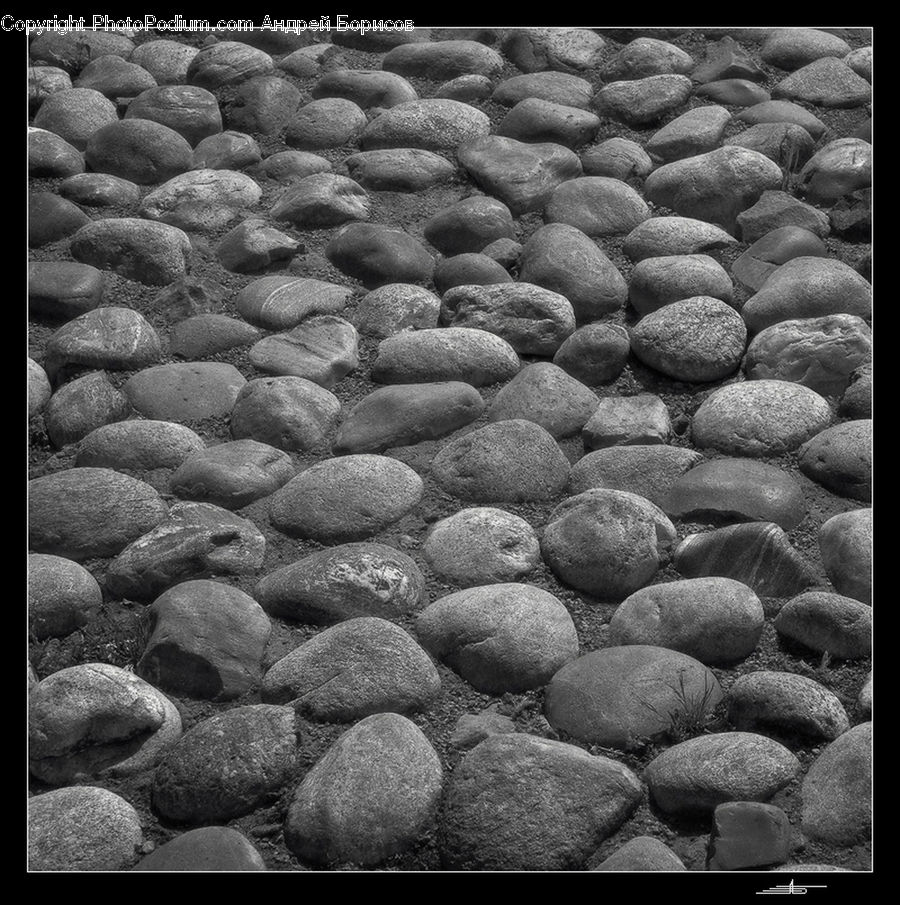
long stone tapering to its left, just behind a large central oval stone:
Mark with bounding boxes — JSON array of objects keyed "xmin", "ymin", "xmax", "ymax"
[{"xmin": 332, "ymin": 381, "xmax": 484, "ymax": 455}]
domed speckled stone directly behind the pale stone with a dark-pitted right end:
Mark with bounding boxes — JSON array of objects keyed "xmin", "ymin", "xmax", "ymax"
[{"xmin": 431, "ymin": 420, "xmax": 569, "ymax": 503}]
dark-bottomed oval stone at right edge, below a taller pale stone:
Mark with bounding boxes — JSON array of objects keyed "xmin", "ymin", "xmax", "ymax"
[{"xmin": 775, "ymin": 591, "xmax": 872, "ymax": 660}]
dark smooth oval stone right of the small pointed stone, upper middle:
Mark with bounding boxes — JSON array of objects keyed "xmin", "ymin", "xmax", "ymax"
[{"xmin": 325, "ymin": 223, "xmax": 434, "ymax": 289}]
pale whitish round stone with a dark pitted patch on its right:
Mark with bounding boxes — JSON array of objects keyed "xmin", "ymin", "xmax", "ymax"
[{"xmin": 422, "ymin": 506, "xmax": 541, "ymax": 588}]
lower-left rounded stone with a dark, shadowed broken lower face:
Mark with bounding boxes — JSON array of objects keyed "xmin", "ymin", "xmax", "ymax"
[{"xmin": 136, "ymin": 579, "xmax": 272, "ymax": 701}]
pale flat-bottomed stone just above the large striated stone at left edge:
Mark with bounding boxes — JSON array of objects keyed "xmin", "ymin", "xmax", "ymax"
[{"xmin": 75, "ymin": 420, "xmax": 206, "ymax": 471}]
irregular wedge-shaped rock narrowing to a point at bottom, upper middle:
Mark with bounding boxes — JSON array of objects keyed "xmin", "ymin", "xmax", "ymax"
[{"xmin": 456, "ymin": 135, "xmax": 582, "ymax": 216}]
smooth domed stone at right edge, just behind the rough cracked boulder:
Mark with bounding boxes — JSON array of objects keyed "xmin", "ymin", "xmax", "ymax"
[{"xmin": 741, "ymin": 256, "xmax": 872, "ymax": 333}]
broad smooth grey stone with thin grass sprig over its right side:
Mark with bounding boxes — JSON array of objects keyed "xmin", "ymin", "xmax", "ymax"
[{"xmin": 544, "ymin": 644, "xmax": 722, "ymax": 750}]
